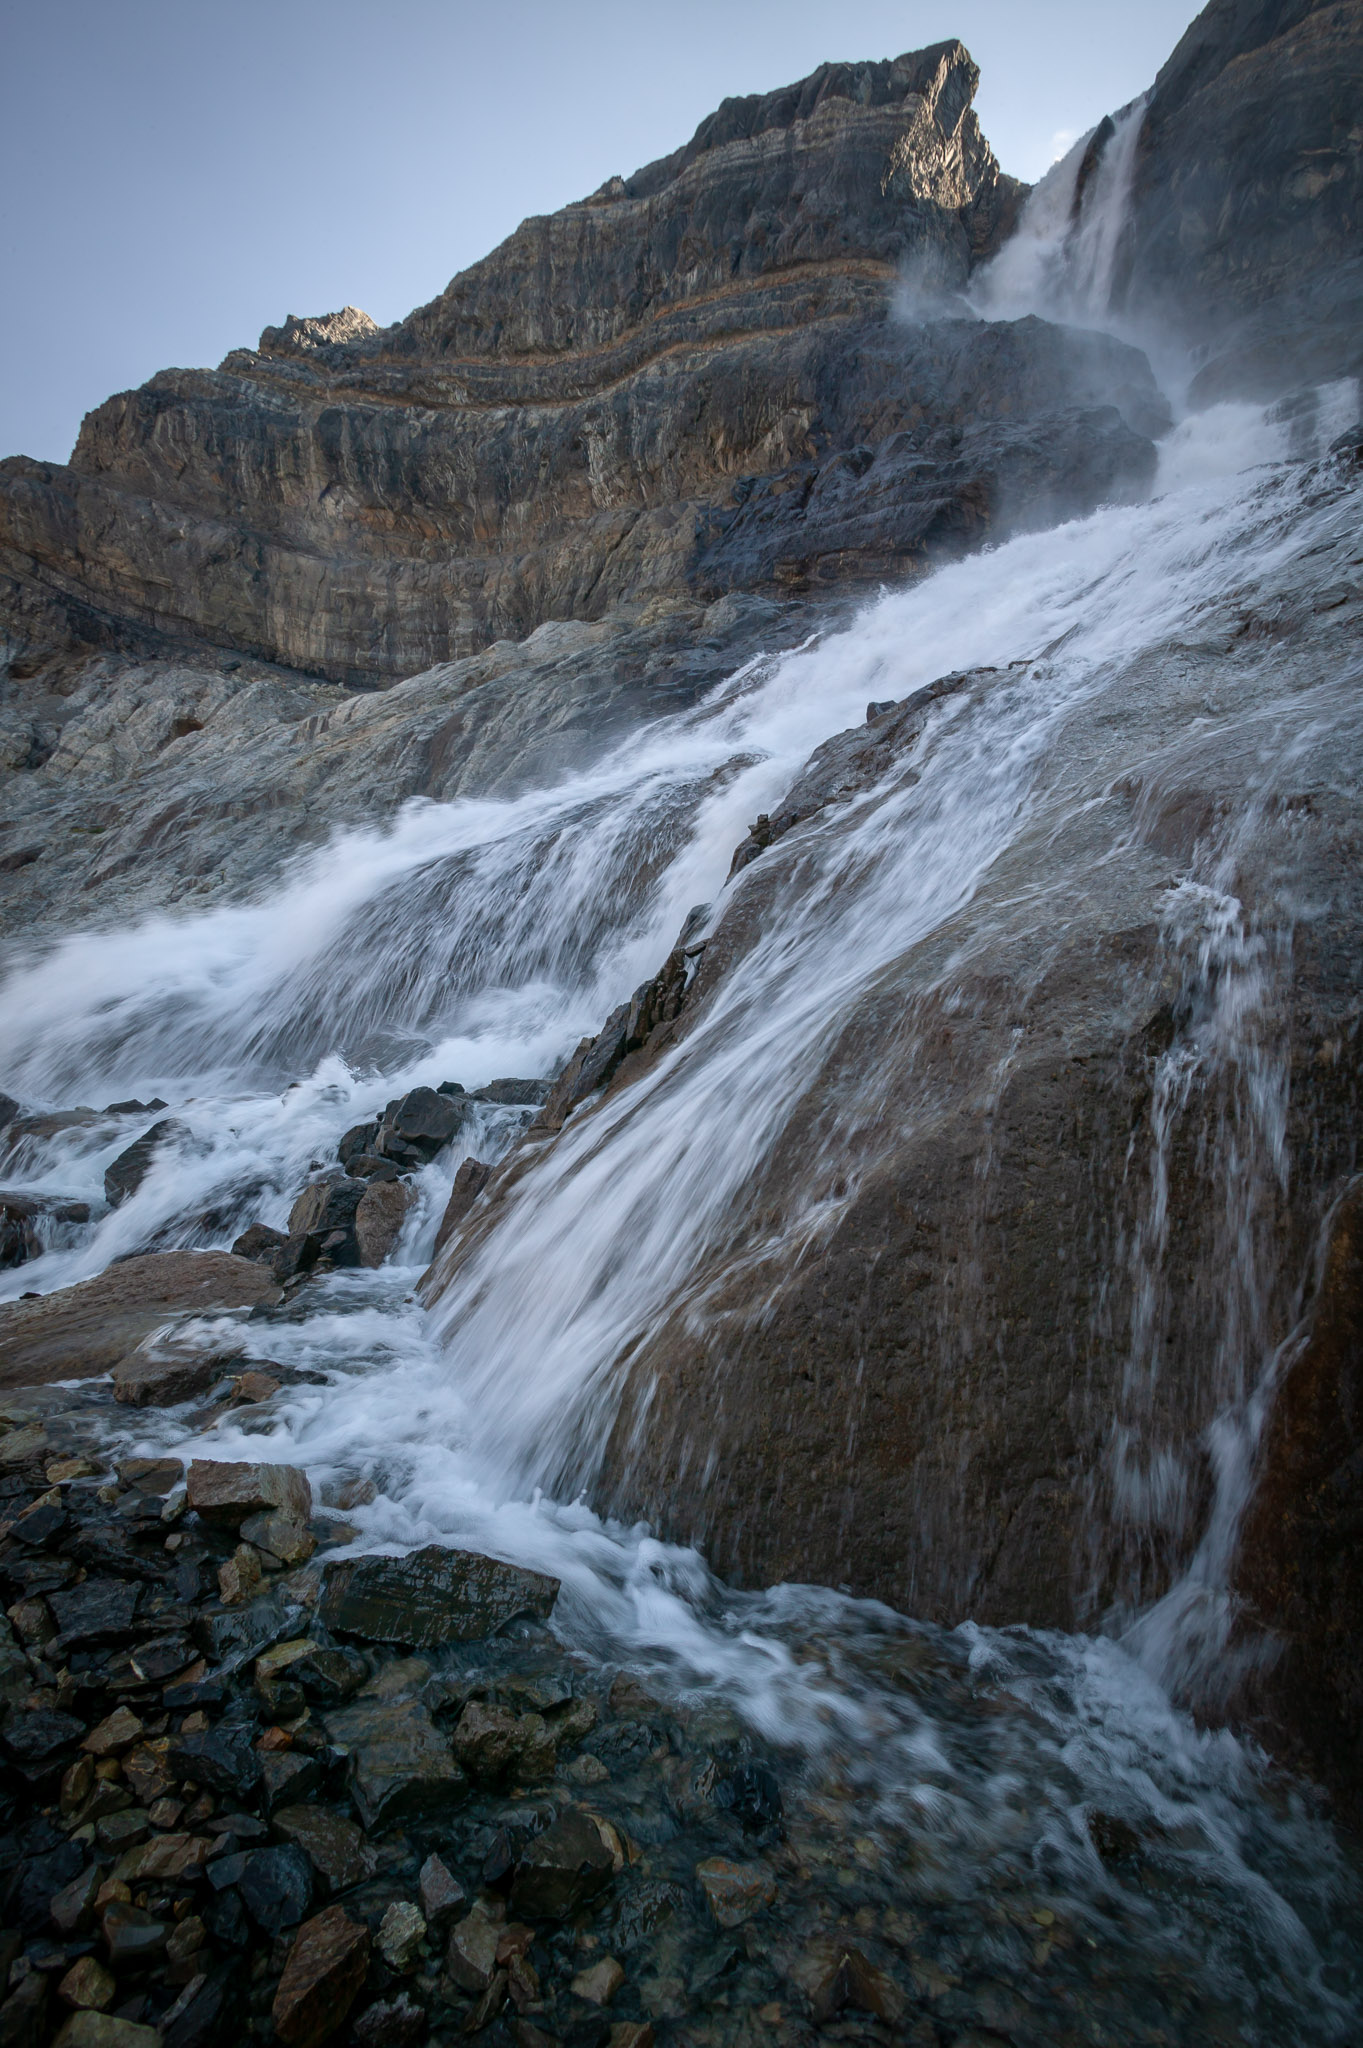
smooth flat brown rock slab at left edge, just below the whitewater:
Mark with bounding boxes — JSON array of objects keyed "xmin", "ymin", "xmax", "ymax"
[{"xmin": 0, "ymin": 1251, "xmax": 280, "ymax": 1386}]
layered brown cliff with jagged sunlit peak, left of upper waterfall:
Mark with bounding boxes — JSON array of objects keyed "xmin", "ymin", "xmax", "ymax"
[{"xmin": 0, "ymin": 43, "xmax": 1167, "ymax": 684}]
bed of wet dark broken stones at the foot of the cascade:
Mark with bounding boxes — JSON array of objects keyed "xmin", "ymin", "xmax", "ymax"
[{"xmin": 0, "ymin": 1386, "xmax": 1350, "ymax": 2048}]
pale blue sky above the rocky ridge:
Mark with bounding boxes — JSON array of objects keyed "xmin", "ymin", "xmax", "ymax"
[{"xmin": 0, "ymin": 0, "xmax": 1197, "ymax": 463}]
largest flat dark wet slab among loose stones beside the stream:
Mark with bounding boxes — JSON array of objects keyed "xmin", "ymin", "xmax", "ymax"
[{"xmin": 321, "ymin": 1544, "xmax": 559, "ymax": 1651}]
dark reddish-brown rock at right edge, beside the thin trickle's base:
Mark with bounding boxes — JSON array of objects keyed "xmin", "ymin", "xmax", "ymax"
[{"xmin": 1238, "ymin": 1186, "xmax": 1363, "ymax": 1810}]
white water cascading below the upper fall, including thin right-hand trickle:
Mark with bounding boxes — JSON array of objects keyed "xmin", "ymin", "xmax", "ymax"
[{"xmin": 0, "ymin": 395, "xmax": 1363, "ymax": 2044}]
